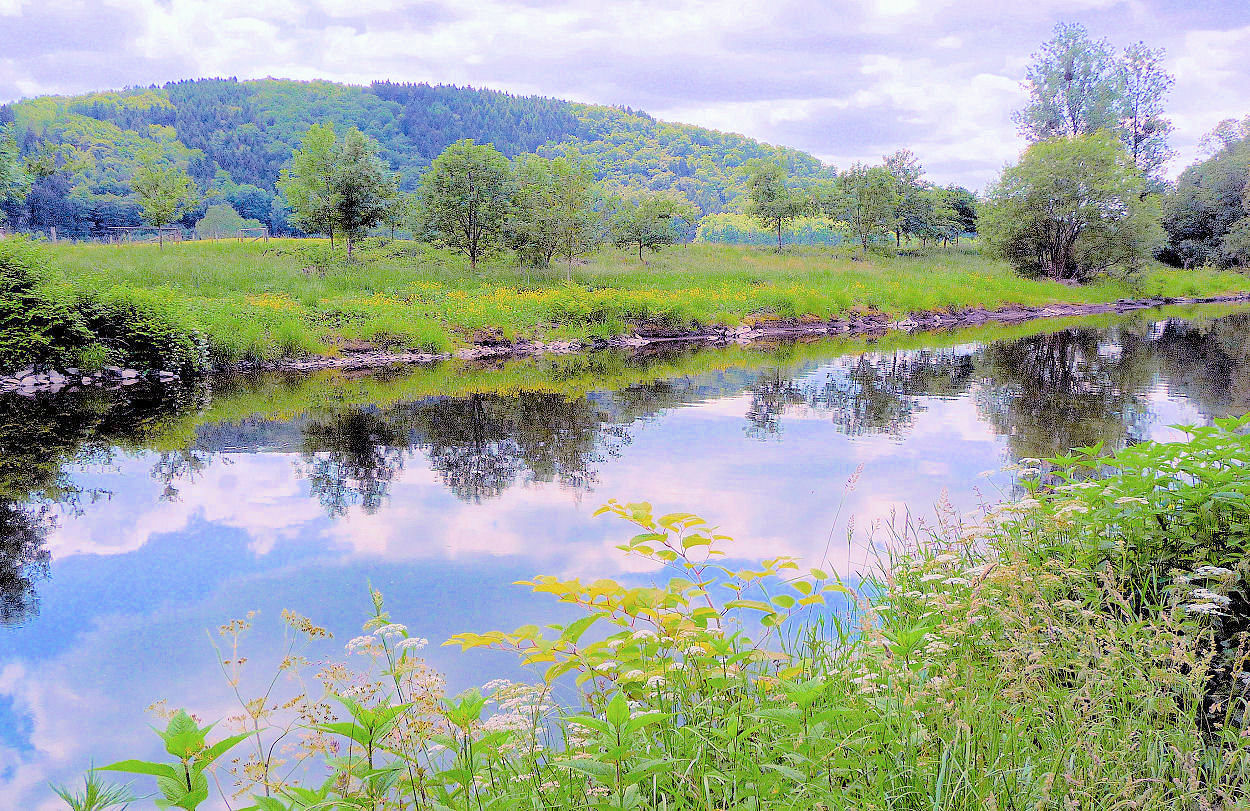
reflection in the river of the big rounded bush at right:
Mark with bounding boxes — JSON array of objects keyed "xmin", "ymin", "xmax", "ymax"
[{"xmin": 978, "ymin": 329, "xmax": 1154, "ymax": 459}]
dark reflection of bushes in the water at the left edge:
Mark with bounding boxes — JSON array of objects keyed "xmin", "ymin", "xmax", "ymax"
[{"xmin": 0, "ymin": 386, "xmax": 194, "ymax": 625}]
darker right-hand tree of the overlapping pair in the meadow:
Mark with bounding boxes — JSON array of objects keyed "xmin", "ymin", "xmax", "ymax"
[{"xmin": 330, "ymin": 127, "xmax": 396, "ymax": 261}]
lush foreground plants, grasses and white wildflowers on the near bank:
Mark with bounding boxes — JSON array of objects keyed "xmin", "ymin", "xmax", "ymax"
[{"xmin": 70, "ymin": 419, "xmax": 1250, "ymax": 811}]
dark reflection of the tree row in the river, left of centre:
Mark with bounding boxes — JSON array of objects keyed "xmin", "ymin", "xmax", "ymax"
[{"xmin": 303, "ymin": 391, "xmax": 629, "ymax": 515}]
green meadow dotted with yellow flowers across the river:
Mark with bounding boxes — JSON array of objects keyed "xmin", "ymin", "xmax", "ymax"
[{"xmin": 53, "ymin": 240, "xmax": 1250, "ymax": 361}]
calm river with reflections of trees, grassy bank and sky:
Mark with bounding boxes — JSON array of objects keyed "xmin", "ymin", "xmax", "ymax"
[{"xmin": 0, "ymin": 303, "xmax": 1250, "ymax": 809}]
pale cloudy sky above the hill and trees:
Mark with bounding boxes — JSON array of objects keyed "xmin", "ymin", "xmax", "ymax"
[{"xmin": 0, "ymin": 0, "xmax": 1250, "ymax": 187}]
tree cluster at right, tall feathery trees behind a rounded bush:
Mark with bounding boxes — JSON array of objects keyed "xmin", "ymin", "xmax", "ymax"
[{"xmin": 981, "ymin": 24, "xmax": 1250, "ymax": 281}]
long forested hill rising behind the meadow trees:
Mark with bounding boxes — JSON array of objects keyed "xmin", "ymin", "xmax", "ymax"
[{"xmin": 0, "ymin": 79, "xmax": 823, "ymax": 237}]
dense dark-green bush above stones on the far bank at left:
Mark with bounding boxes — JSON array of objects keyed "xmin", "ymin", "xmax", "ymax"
[{"xmin": 0, "ymin": 237, "xmax": 209, "ymax": 392}]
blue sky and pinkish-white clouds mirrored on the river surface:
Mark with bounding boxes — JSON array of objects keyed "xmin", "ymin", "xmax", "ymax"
[{"xmin": 0, "ymin": 311, "xmax": 1240, "ymax": 807}]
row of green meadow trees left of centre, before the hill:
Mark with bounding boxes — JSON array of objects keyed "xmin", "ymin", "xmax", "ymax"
[{"xmin": 278, "ymin": 124, "xmax": 698, "ymax": 267}]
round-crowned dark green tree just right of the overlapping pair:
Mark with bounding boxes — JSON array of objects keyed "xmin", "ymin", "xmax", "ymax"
[{"xmin": 420, "ymin": 139, "xmax": 513, "ymax": 267}]
